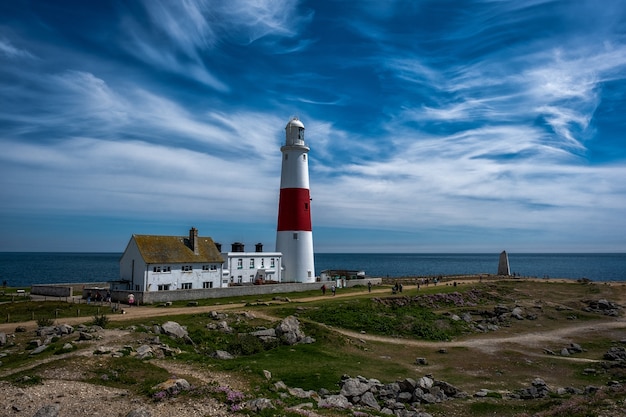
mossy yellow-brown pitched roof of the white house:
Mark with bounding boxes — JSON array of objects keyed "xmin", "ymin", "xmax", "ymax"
[{"xmin": 133, "ymin": 235, "xmax": 224, "ymax": 264}]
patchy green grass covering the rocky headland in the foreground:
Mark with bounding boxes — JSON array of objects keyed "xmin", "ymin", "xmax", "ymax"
[{"xmin": 0, "ymin": 280, "xmax": 626, "ymax": 417}]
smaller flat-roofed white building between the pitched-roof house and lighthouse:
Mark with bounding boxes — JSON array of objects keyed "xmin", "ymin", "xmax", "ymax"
[{"xmin": 222, "ymin": 242, "xmax": 282, "ymax": 287}]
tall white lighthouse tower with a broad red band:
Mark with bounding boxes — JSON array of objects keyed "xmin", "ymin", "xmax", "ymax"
[{"xmin": 276, "ymin": 117, "xmax": 315, "ymax": 282}]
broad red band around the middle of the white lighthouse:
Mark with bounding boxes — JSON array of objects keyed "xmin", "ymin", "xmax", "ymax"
[{"xmin": 278, "ymin": 188, "xmax": 312, "ymax": 232}]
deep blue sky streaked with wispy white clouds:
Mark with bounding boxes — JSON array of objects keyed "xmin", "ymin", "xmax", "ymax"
[{"xmin": 0, "ymin": 0, "xmax": 626, "ymax": 253}]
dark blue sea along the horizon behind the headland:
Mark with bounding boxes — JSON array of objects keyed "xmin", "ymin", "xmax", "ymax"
[{"xmin": 0, "ymin": 252, "xmax": 626, "ymax": 287}]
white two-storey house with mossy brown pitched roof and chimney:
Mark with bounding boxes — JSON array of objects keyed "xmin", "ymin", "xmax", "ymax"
[{"xmin": 116, "ymin": 228, "xmax": 224, "ymax": 292}]
